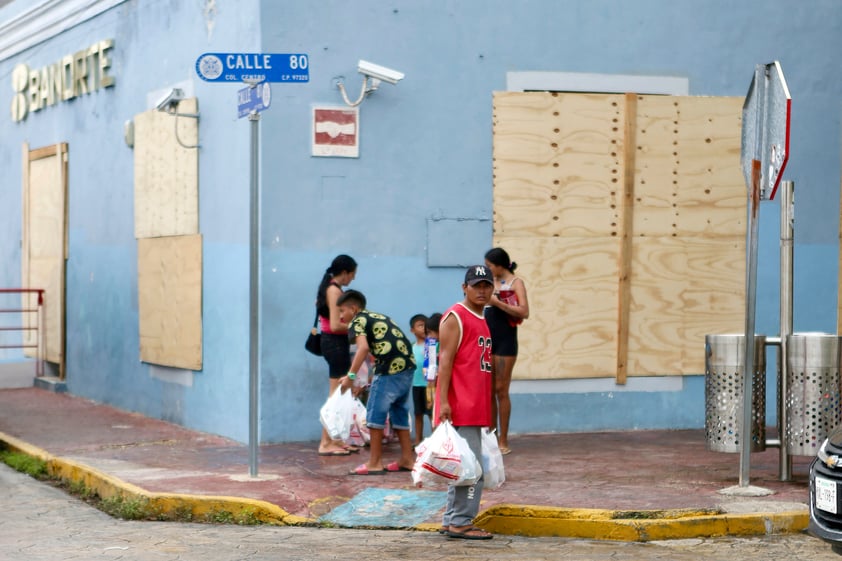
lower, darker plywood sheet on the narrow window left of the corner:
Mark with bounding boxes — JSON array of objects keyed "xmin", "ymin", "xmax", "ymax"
[{"xmin": 137, "ymin": 234, "xmax": 202, "ymax": 370}]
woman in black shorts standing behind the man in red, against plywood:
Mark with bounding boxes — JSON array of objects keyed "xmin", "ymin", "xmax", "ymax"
[{"xmin": 485, "ymin": 247, "xmax": 529, "ymax": 454}]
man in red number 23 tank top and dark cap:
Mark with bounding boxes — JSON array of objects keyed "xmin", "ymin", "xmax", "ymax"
[{"xmin": 435, "ymin": 265, "xmax": 494, "ymax": 540}]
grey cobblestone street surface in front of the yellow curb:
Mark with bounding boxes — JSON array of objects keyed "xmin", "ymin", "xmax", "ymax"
[{"xmin": 0, "ymin": 464, "xmax": 839, "ymax": 561}]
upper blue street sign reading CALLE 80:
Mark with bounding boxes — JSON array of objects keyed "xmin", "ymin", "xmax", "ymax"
[{"xmin": 196, "ymin": 53, "xmax": 310, "ymax": 82}]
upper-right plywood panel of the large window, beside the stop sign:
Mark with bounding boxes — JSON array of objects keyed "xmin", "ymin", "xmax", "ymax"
[{"xmin": 634, "ymin": 95, "xmax": 746, "ymax": 237}]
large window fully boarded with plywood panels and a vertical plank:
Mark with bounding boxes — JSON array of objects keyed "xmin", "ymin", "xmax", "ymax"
[{"xmin": 494, "ymin": 92, "xmax": 746, "ymax": 382}]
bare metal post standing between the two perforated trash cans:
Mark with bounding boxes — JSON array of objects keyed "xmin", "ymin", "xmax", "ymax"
[{"xmin": 778, "ymin": 181, "xmax": 795, "ymax": 481}]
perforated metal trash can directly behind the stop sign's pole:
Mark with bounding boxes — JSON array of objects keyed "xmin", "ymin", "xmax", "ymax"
[{"xmin": 705, "ymin": 335, "xmax": 766, "ymax": 453}]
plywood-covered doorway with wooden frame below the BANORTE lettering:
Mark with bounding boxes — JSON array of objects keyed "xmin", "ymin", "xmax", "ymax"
[{"xmin": 21, "ymin": 143, "xmax": 67, "ymax": 379}]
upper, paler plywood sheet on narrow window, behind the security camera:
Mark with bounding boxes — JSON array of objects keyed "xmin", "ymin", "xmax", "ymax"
[{"xmin": 134, "ymin": 98, "xmax": 199, "ymax": 239}]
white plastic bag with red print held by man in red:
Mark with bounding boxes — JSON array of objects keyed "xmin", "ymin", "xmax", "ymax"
[{"xmin": 412, "ymin": 421, "xmax": 482, "ymax": 487}]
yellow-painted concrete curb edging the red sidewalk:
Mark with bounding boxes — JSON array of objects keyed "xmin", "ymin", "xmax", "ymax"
[{"xmin": 0, "ymin": 432, "xmax": 809, "ymax": 542}]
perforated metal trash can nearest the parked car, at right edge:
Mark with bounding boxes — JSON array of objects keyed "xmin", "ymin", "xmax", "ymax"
[{"xmin": 785, "ymin": 333, "xmax": 842, "ymax": 456}]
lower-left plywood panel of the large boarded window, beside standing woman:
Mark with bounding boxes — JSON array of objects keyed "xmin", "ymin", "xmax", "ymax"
[{"xmin": 495, "ymin": 236, "xmax": 618, "ymax": 379}]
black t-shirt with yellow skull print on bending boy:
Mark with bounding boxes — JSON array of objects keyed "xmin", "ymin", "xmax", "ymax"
[{"xmin": 348, "ymin": 310, "xmax": 415, "ymax": 376}]
